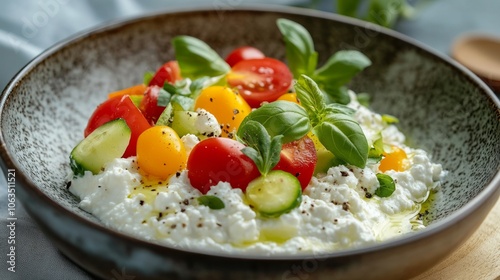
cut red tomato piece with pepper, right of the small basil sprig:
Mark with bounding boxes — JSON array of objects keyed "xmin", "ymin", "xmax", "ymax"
[{"xmin": 273, "ymin": 137, "xmax": 318, "ymax": 190}]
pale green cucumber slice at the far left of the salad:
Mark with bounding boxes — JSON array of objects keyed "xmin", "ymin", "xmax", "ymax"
[{"xmin": 70, "ymin": 119, "xmax": 132, "ymax": 175}]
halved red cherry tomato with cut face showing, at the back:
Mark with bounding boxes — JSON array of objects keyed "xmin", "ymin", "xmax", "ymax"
[{"xmin": 227, "ymin": 57, "xmax": 293, "ymax": 108}]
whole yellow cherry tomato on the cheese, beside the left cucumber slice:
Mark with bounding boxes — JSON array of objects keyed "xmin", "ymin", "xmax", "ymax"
[{"xmin": 137, "ymin": 126, "xmax": 187, "ymax": 179}]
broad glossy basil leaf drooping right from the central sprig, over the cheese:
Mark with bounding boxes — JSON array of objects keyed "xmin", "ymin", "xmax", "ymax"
[{"xmin": 313, "ymin": 113, "xmax": 368, "ymax": 168}]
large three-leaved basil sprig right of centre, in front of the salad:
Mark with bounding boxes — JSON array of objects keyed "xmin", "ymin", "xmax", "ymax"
[{"xmin": 237, "ymin": 75, "xmax": 369, "ymax": 172}]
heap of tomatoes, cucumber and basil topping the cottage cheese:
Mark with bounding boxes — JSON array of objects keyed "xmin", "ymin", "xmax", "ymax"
[{"xmin": 70, "ymin": 19, "xmax": 406, "ymax": 221}]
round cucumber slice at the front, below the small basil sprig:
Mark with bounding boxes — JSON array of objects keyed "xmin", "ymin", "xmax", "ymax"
[{"xmin": 245, "ymin": 170, "xmax": 302, "ymax": 217}]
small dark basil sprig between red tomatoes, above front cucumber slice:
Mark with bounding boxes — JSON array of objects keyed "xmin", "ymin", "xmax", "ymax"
[{"xmin": 238, "ymin": 120, "xmax": 283, "ymax": 175}]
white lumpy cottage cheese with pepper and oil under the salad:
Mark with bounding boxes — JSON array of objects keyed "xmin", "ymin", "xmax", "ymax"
[{"xmin": 70, "ymin": 93, "xmax": 443, "ymax": 255}]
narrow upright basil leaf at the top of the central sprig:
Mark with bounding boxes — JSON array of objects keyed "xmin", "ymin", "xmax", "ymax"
[{"xmin": 294, "ymin": 75, "xmax": 326, "ymax": 126}]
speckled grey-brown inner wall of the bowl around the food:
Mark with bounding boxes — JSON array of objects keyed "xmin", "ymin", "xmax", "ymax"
[{"xmin": 0, "ymin": 10, "xmax": 500, "ymax": 244}]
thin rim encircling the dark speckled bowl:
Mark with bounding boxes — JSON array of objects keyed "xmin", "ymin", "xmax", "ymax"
[{"xmin": 0, "ymin": 4, "xmax": 500, "ymax": 260}]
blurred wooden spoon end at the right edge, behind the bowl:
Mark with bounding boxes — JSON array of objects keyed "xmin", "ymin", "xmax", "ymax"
[{"xmin": 451, "ymin": 34, "xmax": 500, "ymax": 92}]
